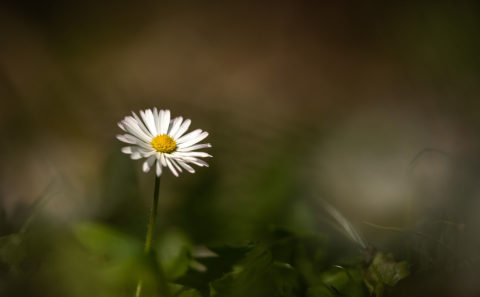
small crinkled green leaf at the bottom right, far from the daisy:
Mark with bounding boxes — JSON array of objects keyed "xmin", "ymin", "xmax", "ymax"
[{"xmin": 365, "ymin": 252, "xmax": 410, "ymax": 297}]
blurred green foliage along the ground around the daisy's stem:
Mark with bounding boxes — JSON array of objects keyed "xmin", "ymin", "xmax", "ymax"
[{"xmin": 0, "ymin": 142, "xmax": 476, "ymax": 297}]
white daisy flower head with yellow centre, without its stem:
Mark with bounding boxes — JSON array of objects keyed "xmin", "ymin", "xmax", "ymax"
[{"xmin": 117, "ymin": 108, "xmax": 212, "ymax": 176}]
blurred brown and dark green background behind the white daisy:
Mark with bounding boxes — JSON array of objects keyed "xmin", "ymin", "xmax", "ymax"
[{"xmin": 0, "ymin": 0, "xmax": 480, "ymax": 296}]
